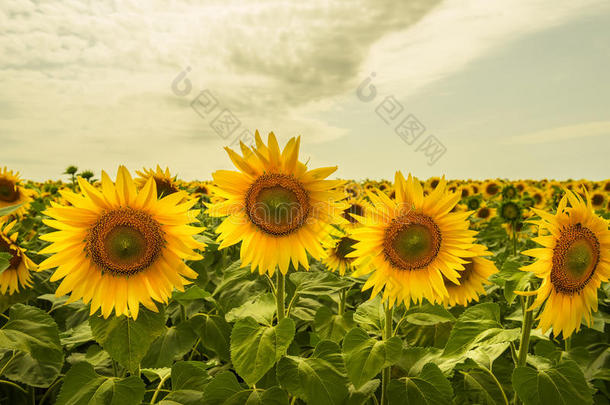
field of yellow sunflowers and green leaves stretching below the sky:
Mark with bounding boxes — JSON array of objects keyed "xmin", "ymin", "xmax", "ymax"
[{"xmin": 0, "ymin": 133, "xmax": 610, "ymax": 405}]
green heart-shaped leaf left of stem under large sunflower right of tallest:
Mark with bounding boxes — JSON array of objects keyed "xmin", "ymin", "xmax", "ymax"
[{"xmin": 343, "ymin": 328, "xmax": 402, "ymax": 388}]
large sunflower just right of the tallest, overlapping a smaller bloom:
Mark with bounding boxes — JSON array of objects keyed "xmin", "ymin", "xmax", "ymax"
[{"xmin": 347, "ymin": 172, "xmax": 475, "ymax": 307}]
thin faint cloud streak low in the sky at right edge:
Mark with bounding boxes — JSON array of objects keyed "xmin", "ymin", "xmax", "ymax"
[{"xmin": 506, "ymin": 121, "xmax": 610, "ymax": 145}]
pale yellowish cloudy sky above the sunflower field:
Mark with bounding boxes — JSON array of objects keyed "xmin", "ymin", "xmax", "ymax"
[{"xmin": 0, "ymin": 0, "xmax": 610, "ymax": 180}]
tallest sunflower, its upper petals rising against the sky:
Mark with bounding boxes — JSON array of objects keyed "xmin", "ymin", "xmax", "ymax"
[{"xmin": 207, "ymin": 132, "xmax": 348, "ymax": 275}]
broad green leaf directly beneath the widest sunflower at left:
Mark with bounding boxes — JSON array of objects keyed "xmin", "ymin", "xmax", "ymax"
[{"xmin": 89, "ymin": 310, "xmax": 165, "ymax": 373}]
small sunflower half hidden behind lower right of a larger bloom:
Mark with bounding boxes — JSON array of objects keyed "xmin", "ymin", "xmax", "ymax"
[{"xmin": 441, "ymin": 244, "xmax": 498, "ymax": 306}]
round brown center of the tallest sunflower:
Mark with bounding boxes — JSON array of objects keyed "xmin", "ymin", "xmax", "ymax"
[{"xmin": 246, "ymin": 173, "xmax": 311, "ymax": 236}]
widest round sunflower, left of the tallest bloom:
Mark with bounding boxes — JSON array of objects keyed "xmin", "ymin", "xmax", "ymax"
[{"xmin": 40, "ymin": 166, "xmax": 205, "ymax": 319}]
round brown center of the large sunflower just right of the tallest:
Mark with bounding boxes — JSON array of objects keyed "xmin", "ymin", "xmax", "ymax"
[{"xmin": 383, "ymin": 213, "xmax": 441, "ymax": 270}]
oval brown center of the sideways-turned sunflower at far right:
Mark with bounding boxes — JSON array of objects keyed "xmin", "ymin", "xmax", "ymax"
[{"xmin": 551, "ymin": 224, "xmax": 600, "ymax": 294}]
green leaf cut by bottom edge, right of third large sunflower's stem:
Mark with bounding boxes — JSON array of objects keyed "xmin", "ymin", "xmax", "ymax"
[{"xmin": 388, "ymin": 363, "xmax": 453, "ymax": 405}]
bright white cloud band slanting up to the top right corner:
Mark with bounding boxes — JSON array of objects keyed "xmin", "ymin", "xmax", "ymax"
[{"xmin": 361, "ymin": 0, "xmax": 608, "ymax": 98}]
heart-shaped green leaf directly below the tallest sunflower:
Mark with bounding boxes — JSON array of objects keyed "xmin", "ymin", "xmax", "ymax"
[{"xmin": 231, "ymin": 317, "xmax": 295, "ymax": 385}]
